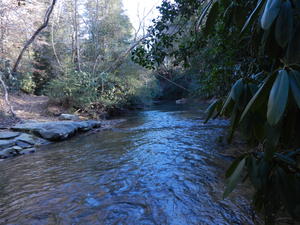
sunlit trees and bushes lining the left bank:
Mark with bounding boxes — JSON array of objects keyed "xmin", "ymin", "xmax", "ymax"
[{"xmin": 0, "ymin": 0, "xmax": 160, "ymax": 116}]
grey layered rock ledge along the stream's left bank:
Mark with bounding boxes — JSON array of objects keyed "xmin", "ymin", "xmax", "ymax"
[{"xmin": 0, "ymin": 120, "xmax": 119, "ymax": 159}]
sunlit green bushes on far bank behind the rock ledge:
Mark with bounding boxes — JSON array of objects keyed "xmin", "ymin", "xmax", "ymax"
[{"xmin": 45, "ymin": 69, "xmax": 159, "ymax": 111}]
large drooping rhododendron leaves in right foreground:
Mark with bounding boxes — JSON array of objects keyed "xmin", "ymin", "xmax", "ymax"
[{"xmin": 204, "ymin": 0, "xmax": 300, "ymax": 223}]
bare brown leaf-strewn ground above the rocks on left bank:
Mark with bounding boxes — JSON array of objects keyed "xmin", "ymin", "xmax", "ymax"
[{"xmin": 0, "ymin": 93, "xmax": 72, "ymax": 128}]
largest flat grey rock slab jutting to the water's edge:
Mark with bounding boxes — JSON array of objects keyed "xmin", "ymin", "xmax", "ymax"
[{"xmin": 12, "ymin": 120, "xmax": 101, "ymax": 141}]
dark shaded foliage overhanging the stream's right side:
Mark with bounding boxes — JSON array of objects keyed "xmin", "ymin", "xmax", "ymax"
[{"xmin": 132, "ymin": 0, "xmax": 300, "ymax": 224}]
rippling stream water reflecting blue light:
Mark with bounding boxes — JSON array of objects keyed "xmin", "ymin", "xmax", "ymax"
[{"xmin": 0, "ymin": 103, "xmax": 254, "ymax": 225}]
